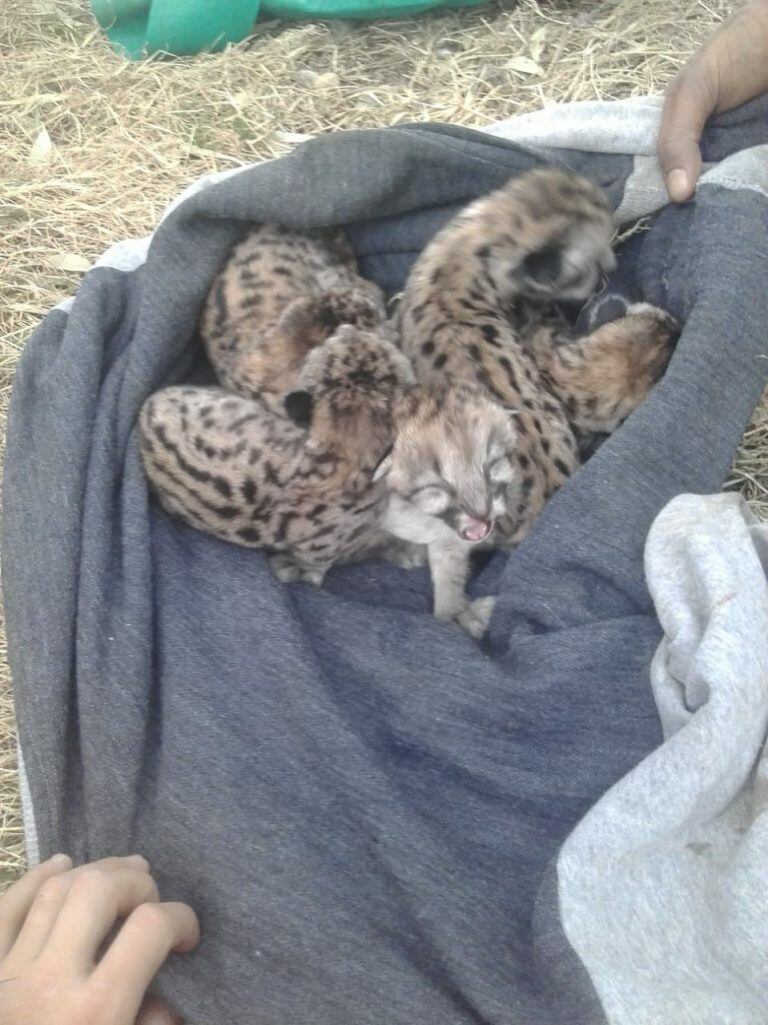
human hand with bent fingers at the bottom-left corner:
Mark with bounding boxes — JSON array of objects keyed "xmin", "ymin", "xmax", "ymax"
[{"xmin": 0, "ymin": 855, "xmax": 200, "ymax": 1025}]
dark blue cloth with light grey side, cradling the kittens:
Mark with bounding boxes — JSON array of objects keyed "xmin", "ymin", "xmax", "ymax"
[{"xmin": 3, "ymin": 100, "xmax": 768, "ymax": 1025}]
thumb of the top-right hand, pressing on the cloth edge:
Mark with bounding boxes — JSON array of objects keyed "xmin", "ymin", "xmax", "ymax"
[{"xmin": 658, "ymin": 73, "xmax": 715, "ymax": 203}]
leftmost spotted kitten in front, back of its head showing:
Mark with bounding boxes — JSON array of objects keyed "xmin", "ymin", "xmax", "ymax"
[{"xmin": 134, "ymin": 326, "xmax": 413, "ymax": 584}]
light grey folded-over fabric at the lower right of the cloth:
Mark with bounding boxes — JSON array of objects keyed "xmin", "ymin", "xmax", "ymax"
[{"xmin": 558, "ymin": 494, "xmax": 768, "ymax": 1025}]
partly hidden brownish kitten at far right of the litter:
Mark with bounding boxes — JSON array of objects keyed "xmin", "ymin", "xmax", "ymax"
[{"xmin": 531, "ymin": 302, "xmax": 679, "ymax": 433}]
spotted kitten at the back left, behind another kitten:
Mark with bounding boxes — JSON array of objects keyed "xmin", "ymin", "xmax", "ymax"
[{"xmin": 200, "ymin": 224, "xmax": 385, "ymax": 415}]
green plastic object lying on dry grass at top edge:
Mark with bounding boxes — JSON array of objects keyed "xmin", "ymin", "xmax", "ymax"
[{"xmin": 91, "ymin": 0, "xmax": 487, "ymax": 60}]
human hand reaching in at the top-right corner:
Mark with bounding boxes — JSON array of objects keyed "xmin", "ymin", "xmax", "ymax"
[{"xmin": 658, "ymin": 0, "xmax": 768, "ymax": 203}]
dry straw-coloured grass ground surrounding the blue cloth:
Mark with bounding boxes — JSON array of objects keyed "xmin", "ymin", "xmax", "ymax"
[{"xmin": 0, "ymin": 0, "xmax": 754, "ymax": 886}]
